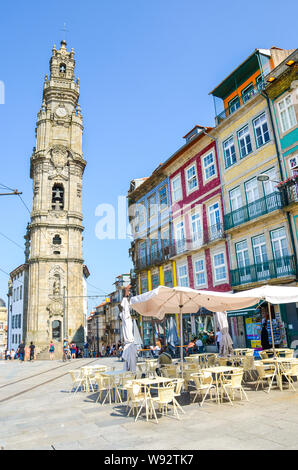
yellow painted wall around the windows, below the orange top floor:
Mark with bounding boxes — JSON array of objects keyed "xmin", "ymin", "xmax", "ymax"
[{"xmin": 213, "ymin": 81, "xmax": 294, "ymax": 290}]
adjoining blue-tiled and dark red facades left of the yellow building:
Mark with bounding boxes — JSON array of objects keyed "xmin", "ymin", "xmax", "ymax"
[{"xmin": 129, "ymin": 126, "xmax": 230, "ymax": 344}]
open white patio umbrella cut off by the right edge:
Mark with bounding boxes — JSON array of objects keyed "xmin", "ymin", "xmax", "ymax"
[{"xmin": 234, "ymin": 284, "xmax": 298, "ymax": 356}]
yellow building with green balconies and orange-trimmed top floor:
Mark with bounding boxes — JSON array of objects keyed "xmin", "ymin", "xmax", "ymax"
[{"xmin": 211, "ymin": 48, "xmax": 297, "ymax": 347}]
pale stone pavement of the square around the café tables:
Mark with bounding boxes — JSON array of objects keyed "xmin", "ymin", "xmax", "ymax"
[{"xmin": 0, "ymin": 358, "xmax": 298, "ymax": 450}]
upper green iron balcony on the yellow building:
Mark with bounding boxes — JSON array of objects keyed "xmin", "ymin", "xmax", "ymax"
[{"xmin": 224, "ymin": 192, "xmax": 285, "ymax": 230}]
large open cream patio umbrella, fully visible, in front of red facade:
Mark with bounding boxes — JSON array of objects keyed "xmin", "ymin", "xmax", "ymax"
[{"xmin": 130, "ymin": 286, "xmax": 255, "ymax": 367}]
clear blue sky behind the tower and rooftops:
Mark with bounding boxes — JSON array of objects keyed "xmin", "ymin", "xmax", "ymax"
[{"xmin": 0, "ymin": 0, "xmax": 298, "ymax": 309}]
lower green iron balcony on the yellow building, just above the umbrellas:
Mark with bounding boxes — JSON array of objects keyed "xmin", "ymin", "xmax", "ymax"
[{"xmin": 231, "ymin": 256, "xmax": 296, "ymax": 287}]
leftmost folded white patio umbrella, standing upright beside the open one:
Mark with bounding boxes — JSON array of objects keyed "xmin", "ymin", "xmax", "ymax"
[{"xmin": 120, "ymin": 297, "xmax": 138, "ymax": 372}]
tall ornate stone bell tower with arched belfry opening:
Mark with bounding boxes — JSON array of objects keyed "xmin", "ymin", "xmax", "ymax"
[{"xmin": 26, "ymin": 41, "xmax": 86, "ymax": 349}]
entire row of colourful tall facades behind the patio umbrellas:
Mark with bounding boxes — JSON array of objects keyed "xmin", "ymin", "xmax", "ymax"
[{"xmin": 128, "ymin": 47, "xmax": 298, "ymax": 347}]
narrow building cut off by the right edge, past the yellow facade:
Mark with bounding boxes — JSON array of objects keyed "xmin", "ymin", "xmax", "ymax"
[{"xmin": 266, "ymin": 50, "xmax": 298, "ymax": 347}]
